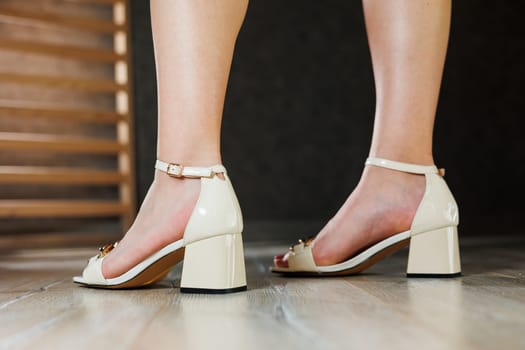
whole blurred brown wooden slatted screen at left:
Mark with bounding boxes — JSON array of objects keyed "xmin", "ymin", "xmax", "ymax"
[{"xmin": 0, "ymin": 0, "xmax": 135, "ymax": 247}]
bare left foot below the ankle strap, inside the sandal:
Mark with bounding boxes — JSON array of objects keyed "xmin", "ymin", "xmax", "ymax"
[{"xmin": 102, "ymin": 171, "xmax": 200, "ymax": 278}]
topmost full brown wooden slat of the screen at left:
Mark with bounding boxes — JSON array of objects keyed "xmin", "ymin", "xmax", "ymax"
[{"xmin": 0, "ymin": 5, "xmax": 125, "ymax": 33}]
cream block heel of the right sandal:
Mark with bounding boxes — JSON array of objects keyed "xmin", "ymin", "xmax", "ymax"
[{"xmin": 407, "ymin": 226, "xmax": 461, "ymax": 277}]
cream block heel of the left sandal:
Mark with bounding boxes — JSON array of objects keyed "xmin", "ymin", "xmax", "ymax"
[{"xmin": 180, "ymin": 233, "xmax": 246, "ymax": 294}]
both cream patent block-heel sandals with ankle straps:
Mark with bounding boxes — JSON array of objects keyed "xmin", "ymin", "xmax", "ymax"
[{"xmin": 73, "ymin": 157, "xmax": 461, "ymax": 294}]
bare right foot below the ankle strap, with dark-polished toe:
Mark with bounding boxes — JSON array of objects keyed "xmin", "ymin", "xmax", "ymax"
[{"xmin": 274, "ymin": 166, "xmax": 425, "ymax": 267}]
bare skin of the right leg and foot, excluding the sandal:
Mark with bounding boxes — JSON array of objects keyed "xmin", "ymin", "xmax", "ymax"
[{"xmin": 275, "ymin": 0, "xmax": 451, "ymax": 266}]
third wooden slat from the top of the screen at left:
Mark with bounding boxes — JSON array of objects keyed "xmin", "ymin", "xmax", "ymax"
[{"xmin": 0, "ymin": 72, "xmax": 127, "ymax": 93}]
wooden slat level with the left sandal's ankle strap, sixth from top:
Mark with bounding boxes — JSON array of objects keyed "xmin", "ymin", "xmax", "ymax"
[{"xmin": 0, "ymin": 166, "xmax": 127, "ymax": 185}]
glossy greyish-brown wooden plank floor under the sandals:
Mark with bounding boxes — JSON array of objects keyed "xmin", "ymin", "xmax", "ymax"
[{"xmin": 0, "ymin": 240, "xmax": 525, "ymax": 350}]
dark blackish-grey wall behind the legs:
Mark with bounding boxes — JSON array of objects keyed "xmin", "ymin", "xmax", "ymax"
[{"xmin": 132, "ymin": 0, "xmax": 525, "ymax": 238}]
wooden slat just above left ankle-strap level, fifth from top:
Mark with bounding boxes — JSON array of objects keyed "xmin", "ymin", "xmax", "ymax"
[{"xmin": 0, "ymin": 132, "xmax": 125, "ymax": 154}]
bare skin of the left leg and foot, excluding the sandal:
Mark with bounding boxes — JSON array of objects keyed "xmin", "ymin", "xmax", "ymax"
[{"xmin": 102, "ymin": 0, "xmax": 248, "ymax": 278}]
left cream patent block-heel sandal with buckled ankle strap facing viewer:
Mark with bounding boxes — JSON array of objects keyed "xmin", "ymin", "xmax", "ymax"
[{"xmin": 73, "ymin": 160, "xmax": 246, "ymax": 294}]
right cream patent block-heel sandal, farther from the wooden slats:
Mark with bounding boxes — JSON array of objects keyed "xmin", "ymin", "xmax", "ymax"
[{"xmin": 271, "ymin": 158, "xmax": 461, "ymax": 277}]
